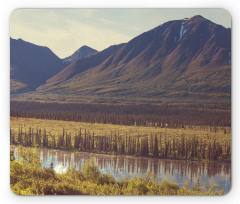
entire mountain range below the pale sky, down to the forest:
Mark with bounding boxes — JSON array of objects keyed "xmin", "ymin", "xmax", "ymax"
[{"xmin": 11, "ymin": 16, "xmax": 231, "ymax": 106}]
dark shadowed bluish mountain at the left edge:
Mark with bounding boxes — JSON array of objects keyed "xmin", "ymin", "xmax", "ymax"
[{"xmin": 10, "ymin": 38, "xmax": 64, "ymax": 93}]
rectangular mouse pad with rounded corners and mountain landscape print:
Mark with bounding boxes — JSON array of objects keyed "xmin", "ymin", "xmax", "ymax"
[{"xmin": 10, "ymin": 8, "xmax": 231, "ymax": 195}]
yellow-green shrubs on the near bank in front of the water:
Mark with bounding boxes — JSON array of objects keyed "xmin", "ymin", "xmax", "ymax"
[{"xmin": 10, "ymin": 146, "xmax": 224, "ymax": 195}]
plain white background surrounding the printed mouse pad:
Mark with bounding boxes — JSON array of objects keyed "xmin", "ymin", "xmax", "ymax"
[{"xmin": 0, "ymin": 0, "xmax": 240, "ymax": 204}]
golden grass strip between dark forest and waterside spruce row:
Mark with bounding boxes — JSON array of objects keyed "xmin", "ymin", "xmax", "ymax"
[{"xmin": 10, "ymin": 117, "xmax": 231, "ymax": 145}]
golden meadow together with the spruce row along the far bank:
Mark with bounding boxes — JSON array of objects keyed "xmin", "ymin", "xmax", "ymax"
[{"xmin": 10, "ymin": 117, "xmax": 231, "ymax": 162}]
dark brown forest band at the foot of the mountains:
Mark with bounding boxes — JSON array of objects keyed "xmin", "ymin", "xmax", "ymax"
[{"xmin": 10, "ymin": 101, "xmax": 231, "ymax": 128}]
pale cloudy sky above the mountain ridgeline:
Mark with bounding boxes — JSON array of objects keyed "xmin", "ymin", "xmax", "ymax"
[{"xmin": 10, "ymin": 9, "xmax": 231, "ymax": 58}]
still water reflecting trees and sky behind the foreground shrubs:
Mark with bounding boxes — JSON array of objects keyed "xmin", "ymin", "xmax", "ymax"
[{"xmin": 11, "ymin": 147, "xmax": 231, "ymax": 193}]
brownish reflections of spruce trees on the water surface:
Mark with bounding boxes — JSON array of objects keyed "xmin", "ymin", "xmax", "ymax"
[{"xmin": 20, "ymin": 149, "xmax": 231, "ymax": 182}]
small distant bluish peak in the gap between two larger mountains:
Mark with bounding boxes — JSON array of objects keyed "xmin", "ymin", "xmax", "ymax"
[{"xmin": 63, "ymin": 45, "xmax": 97, "ymax": 65}]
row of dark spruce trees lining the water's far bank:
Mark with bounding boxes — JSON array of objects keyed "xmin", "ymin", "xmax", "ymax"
[{"xmin": 10, "ymin": 125, "xmax": 231, "ymax": 162}]
